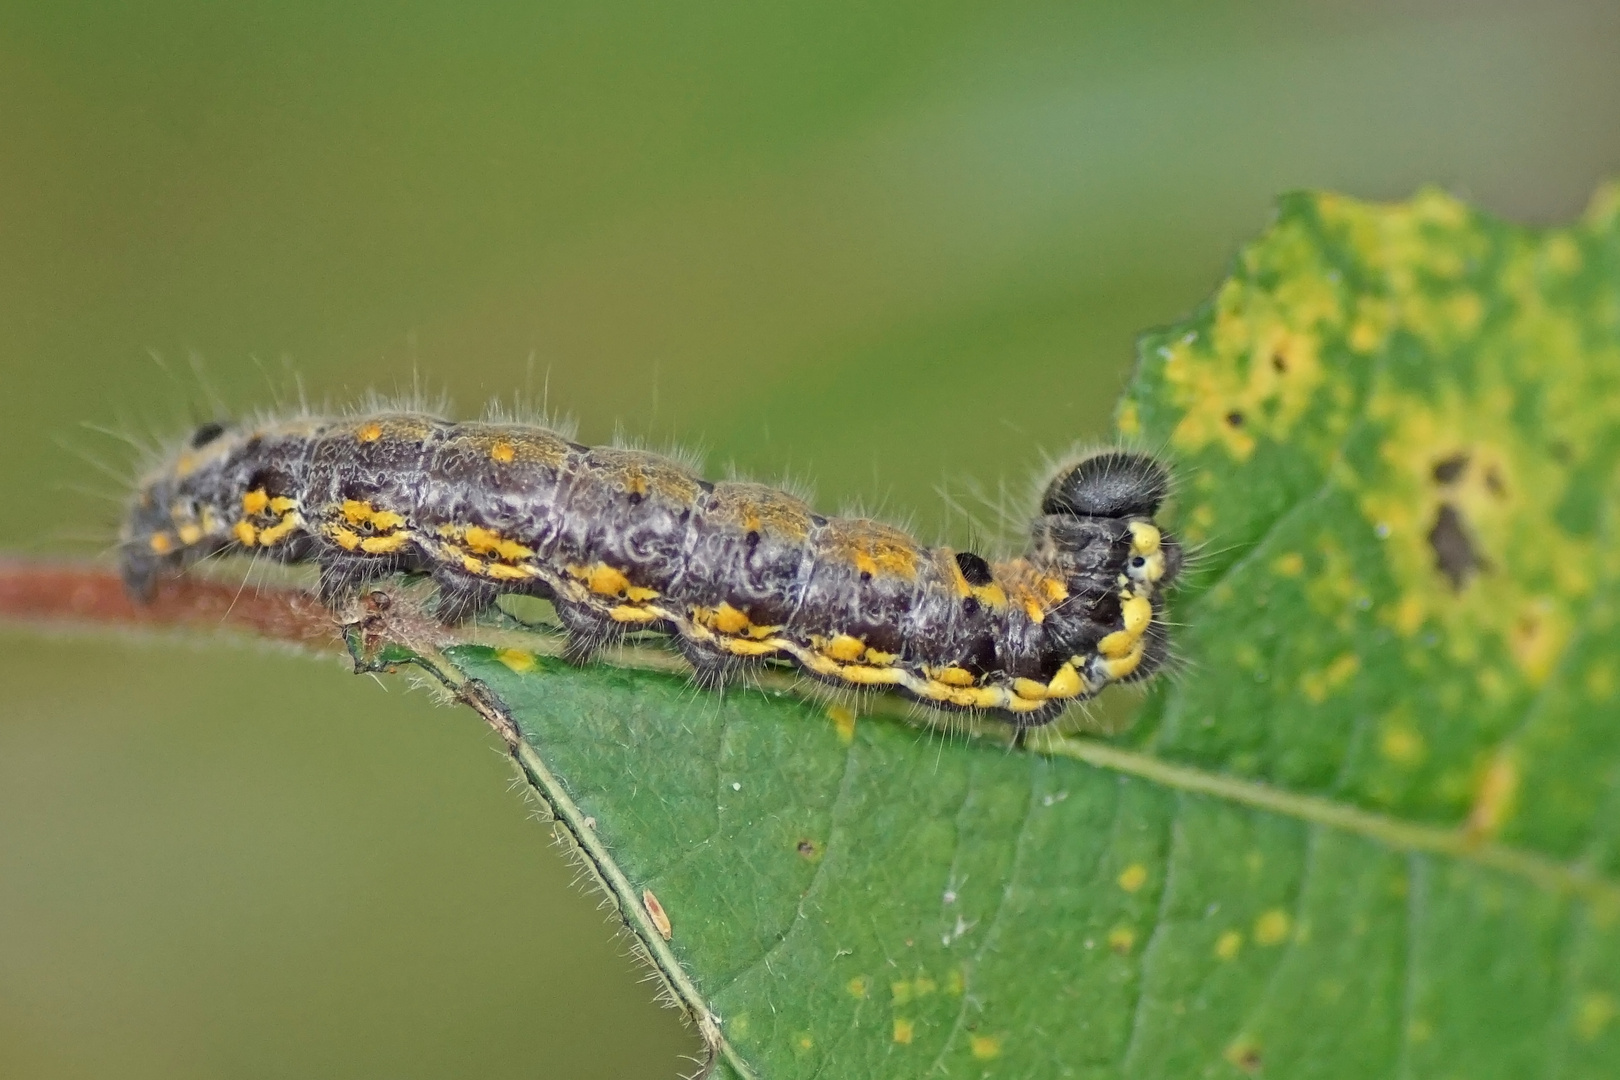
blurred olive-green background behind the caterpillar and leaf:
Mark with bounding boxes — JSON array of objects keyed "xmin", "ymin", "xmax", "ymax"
[{"xmin": 0, "ymin": 0, "xmax": 1620, "ymax": 1078}]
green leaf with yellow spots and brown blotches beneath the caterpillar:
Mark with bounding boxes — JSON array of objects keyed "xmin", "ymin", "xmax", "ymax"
[{"xmin": 361, "ymin": 189, "xmax": 1620, "ymax": 1080}]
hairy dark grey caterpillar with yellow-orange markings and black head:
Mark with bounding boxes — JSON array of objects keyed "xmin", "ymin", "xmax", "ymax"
[{"xmin": 120, "ymin": 411, "xmax": 1181, "ymax": 727}]
